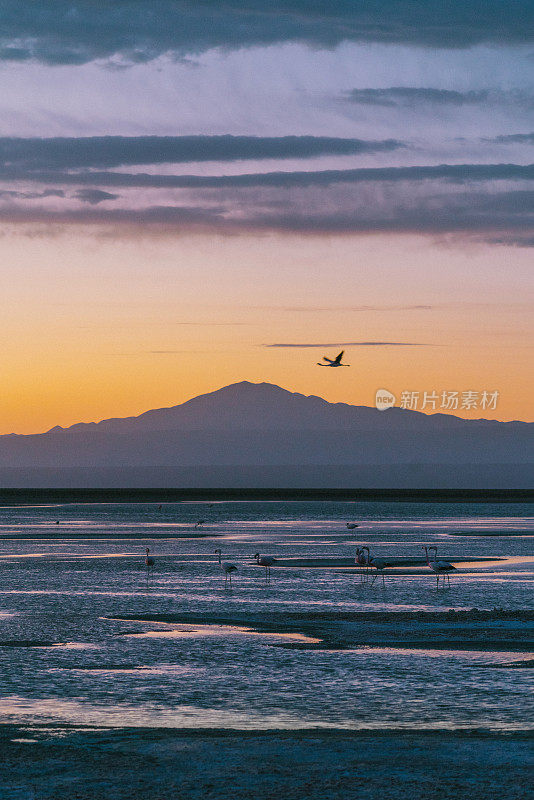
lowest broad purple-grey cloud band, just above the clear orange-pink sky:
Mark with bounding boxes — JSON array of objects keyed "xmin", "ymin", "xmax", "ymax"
[{"xmin": 0, "ymin": 182, "xmax": 534, "ymax": 244}]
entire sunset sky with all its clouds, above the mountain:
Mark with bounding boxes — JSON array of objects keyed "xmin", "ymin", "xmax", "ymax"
[{"xmin": 0, "ymin": 0, "xmax": 534, "ymax": 433}]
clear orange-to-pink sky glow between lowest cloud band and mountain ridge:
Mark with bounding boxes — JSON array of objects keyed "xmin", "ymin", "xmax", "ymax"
[{"xmin": 0, "ymin": 229, "xmax": 534, "ymax": 433}]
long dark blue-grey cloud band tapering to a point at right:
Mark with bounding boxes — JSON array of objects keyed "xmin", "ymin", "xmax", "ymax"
[{"xmin": 0, "ymin": 136, "xmax": 404, "ymax": 170}]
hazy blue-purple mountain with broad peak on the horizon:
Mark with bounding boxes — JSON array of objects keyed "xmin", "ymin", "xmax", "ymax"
[{"xmin": 0, "ymin": 382, "xmax": 534, "ymax": 488}]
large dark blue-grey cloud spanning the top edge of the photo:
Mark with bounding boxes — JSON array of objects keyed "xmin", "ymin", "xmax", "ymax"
[{"xmin": 0, "ymin": 0, "xmax": 534, "ymax": 66}]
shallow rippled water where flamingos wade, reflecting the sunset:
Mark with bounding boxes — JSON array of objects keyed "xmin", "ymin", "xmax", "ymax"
[{"xmin": 0, "ymin": 501, "xmax": 534, "ymax": 730}]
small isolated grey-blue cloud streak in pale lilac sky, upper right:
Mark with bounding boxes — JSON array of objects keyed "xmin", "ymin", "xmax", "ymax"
[{"xmin": 346, "ymin": 86, "xmax": 490, "ymax": 106}]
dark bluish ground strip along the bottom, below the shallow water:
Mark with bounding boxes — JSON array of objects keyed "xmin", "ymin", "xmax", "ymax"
[{"xmin": 0, "ymin": 728, "xmax": 533, "ymax": 800}]
